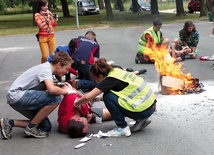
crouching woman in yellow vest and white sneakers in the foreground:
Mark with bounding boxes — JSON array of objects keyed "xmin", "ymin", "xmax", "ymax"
[{"xmin": 74, "ymin": 58, "xmax": 156, "ymax": 137}]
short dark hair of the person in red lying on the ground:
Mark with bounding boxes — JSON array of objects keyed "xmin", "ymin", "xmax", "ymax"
[{"xmin": 68, "ymin": 119, "xmax": 87, "ymax": 138}]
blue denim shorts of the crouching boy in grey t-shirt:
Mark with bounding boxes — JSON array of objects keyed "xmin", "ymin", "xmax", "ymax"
[{"xmin": 10, "ymin": 90, "xmax": 62, "ymax": 132}]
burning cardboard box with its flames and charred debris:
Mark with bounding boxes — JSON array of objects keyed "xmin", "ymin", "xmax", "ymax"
[{"xmin": 145, "ymin": 45, "xmax": 204, "ymax": 95}]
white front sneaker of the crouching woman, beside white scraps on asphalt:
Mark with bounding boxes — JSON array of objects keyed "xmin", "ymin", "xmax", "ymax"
[{"xmin": 107, "ymin": 126, "xmax": 131, "ymax": 137}]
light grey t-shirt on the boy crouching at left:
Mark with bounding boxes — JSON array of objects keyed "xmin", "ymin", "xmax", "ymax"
[{"xmin": 6, "ymin": 62, "xmax": 53, "ymax": 104}]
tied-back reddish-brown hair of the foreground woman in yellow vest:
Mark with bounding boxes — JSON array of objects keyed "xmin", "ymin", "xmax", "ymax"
[{"xmin": 90, "ymin": 58, "xmax": 113, "ymax": 77}]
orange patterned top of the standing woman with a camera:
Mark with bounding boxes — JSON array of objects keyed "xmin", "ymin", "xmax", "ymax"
[{"xmin": 34, "ymin": 13, "xmax": 56, "ymax": 37}]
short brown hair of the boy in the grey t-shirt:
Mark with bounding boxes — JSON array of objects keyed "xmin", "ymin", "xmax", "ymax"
[{"xmin": 52, "ymin": 51, "xmax": 73, "ymax": 67}]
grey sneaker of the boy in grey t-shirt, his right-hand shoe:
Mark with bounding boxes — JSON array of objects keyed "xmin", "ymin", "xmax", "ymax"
[{"xmin": 24, "ymin": 126, "xmax": 48, "ymax": 138}]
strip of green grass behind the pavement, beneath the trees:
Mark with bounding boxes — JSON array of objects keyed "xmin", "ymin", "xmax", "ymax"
[{"xmin": 0, "ymin": 4, "xmax": 208, "ymax": 36}]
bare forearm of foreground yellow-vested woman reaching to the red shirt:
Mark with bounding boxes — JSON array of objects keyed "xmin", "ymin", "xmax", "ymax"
[{"xmin": 74, "ymin": 88, "xmax": 103, "ymax": 107}]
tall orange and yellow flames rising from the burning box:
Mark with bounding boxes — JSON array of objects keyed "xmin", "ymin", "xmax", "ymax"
[{"xmin": 144, "ymin": 43, "xmax": 194, "ymax": 94}]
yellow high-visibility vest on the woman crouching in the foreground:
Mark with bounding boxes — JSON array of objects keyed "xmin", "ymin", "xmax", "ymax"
[{"xmin": 107, "ymin": 68, "xmax": 155, "ymax": 112}]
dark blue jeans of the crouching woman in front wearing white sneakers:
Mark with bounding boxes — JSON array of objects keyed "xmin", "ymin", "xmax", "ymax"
[{"xmin": 103, "ymin": 92, "xmax": 155, "ymax": 128}]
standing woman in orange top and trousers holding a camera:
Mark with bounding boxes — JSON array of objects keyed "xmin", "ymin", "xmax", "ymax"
[{"xmin": 34, "ymin": 0, "xmax": 58, "ymax": 63}]
